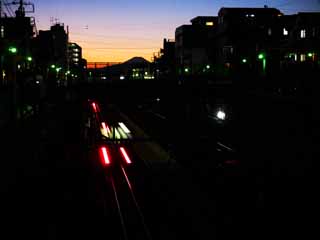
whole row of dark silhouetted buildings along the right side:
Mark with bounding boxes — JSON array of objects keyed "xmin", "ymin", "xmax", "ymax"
[{"xmin": 162, "ymin": 6, "xmax": 320, "ymax": 85}]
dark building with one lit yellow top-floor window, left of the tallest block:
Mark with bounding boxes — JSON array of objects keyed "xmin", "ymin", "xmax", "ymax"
[{"xmin": 175, "ymin": 16, "xmax": 218, "ymax": 75}]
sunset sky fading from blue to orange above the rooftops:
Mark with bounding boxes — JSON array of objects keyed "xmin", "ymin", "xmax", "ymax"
[{"xmin": 28, "ymin": 0, "xmax": 320, "ymax": 62}]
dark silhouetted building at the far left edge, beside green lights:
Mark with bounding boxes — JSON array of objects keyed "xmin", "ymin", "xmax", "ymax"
[{"xmin": 0, "ymin": 8, "xmax": 36, "ymax": 126}]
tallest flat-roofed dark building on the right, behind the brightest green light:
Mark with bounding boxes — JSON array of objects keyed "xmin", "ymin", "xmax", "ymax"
[{"xmin": 215, "ymin": 8, "xmax": 283, "ymax": 77}]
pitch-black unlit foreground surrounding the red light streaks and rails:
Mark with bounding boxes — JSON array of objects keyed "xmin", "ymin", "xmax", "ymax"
[{"xmin": 0, "ymin": 83, "xmax": 320, "ymax": 239}]
